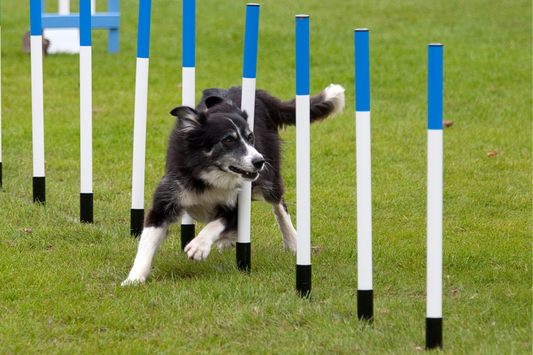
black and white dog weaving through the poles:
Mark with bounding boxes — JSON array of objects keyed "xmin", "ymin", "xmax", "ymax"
[{"xmin": 122, "ymin": 84, "xmax": 344, "ymax": 285}]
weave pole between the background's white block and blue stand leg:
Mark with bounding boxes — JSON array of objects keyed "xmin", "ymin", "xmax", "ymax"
[{"xmin": 80, "ymin": 0, "xmax": 93, "ymax": 223}]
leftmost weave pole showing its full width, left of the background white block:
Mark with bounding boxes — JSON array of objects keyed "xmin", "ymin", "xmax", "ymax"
[{"xmin": 30, "ymin": 0, "xmax": 46, "ymax": 204}]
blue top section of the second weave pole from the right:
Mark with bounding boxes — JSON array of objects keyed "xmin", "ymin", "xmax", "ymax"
[{"xmin": 354, "ymin": 28, "xmax": 370, "ymax": 111}]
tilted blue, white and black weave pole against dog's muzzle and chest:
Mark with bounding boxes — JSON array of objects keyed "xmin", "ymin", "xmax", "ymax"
[{"xmin": 236, "ymin": 4, "xmax": 259, "ymax": 272}]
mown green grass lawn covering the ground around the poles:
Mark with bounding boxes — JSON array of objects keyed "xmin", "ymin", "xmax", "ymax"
[{"xmin": 0, "ymin": 0, "xmax": 533, "ymax": 354}]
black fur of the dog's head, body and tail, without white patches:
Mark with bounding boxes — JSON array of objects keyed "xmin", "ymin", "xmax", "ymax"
[{"xmin": 145, "ymin": 87, "xmax": 344, "ymax": 245}]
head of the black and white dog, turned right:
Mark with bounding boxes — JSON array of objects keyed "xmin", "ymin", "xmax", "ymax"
[{"xmin": 170, "ymin": 96, "xmax": 265, "ymax": 185}]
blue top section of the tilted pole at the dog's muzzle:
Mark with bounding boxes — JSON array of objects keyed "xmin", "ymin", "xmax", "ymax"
[{"xmin": 242, "ymin": 4, "xmax": 259, "ymax": 79}]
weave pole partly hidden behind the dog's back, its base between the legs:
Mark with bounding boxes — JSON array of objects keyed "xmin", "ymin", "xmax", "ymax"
[{"xmin": 181, "ymin": 0, "xmax": 196, "ymax": 249}]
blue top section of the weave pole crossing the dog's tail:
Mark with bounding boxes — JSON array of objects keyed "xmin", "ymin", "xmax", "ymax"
[{"xmin": 296, "ymin": 15, "xmax": 310, "ymax": 95}]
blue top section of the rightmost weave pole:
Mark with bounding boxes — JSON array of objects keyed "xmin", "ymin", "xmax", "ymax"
[{"xmin": 428, "ymin": 43, "xmax": 444, "ymax": 129}]
